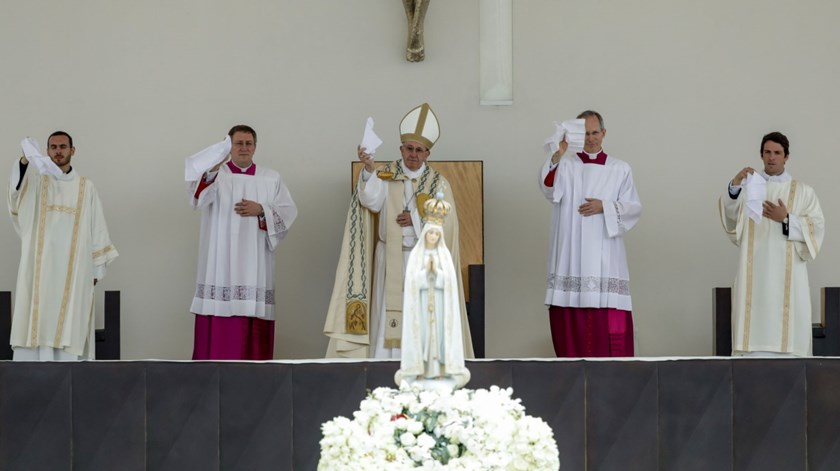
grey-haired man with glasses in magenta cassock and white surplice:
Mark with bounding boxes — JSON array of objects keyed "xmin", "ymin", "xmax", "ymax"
[{"xmin": 539, "ymin": 110, "xmax": 642, "ymax": 357}]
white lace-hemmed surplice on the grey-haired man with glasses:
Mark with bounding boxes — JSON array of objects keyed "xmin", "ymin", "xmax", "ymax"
[{"xmin": 539, "ymin": 152, "xmax": 642, "ymax": 311}]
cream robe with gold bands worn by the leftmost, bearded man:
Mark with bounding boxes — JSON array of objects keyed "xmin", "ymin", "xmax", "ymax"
[{"xmin": 8, "ymin": 161, "xmax": 118, "ymax": 359}]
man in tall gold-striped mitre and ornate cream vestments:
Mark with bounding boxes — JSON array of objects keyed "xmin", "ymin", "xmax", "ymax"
[{"xmin": 324, "ymin": 103, "xmax": 473, "ymax": 358}]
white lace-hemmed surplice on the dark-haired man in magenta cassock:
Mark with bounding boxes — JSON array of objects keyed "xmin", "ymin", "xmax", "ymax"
[{"xmin": 190, "ymin": 163, "xmax": 297, "ymax": 321}]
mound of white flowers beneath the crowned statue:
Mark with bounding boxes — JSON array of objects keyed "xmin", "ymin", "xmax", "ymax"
[{"xmin": 318, "ymin": 383, "xmax": 560, "ymax": 471}]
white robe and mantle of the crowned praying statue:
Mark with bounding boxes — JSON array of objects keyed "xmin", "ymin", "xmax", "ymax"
[{"xmin": 394, "ymin": 224, "xmax": 470, "ymax": 387}]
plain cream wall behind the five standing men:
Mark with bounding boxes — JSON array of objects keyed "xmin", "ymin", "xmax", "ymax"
[{"xmin": 0, "ymin": 0, "xmax": 840, "ymax": 359}]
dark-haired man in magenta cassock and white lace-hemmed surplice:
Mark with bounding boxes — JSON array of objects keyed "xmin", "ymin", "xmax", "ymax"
[{"xmin": 186, "ymin": 125, "xmax": 297, "ymax": 360}]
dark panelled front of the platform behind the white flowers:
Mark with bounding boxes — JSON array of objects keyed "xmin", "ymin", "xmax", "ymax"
[{"xmin": 0, "ymin": 358, "xmax": 840, "ymax": 471}]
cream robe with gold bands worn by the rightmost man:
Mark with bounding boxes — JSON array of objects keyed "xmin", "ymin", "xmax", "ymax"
[{"xmin": 719, "ymin": 172, "xmax": 825, "ymax": 356}]
